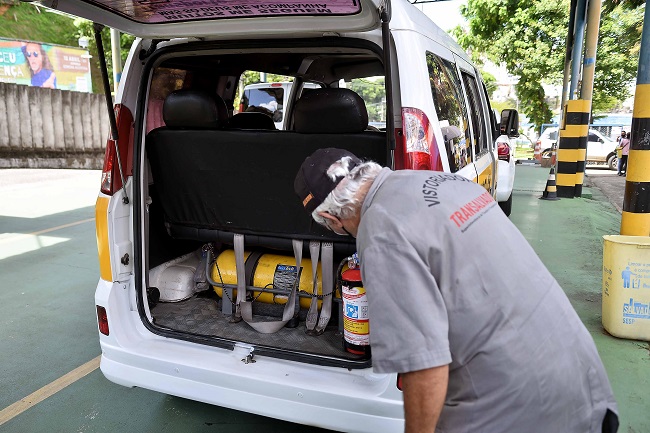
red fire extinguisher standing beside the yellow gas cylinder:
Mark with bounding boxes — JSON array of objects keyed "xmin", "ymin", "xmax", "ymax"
[{"xmin": 341, "ymin": 254, "xmax": 370, "ymax": 359}]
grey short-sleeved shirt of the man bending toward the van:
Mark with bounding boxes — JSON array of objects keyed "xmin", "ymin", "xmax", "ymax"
[{"xmin": 357, "ymin": 169, "xmax": 616, "ymax": 433}]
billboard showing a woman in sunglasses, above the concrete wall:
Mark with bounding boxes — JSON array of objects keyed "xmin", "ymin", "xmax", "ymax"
[{"xmin": 0, "ymin": 38, "xmax": 92, "ymax": 92}]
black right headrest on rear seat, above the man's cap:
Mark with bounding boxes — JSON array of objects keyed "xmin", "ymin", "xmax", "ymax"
[{"xmin": 294, "ymin": 88, "xmax": 368, "ymax": 134}]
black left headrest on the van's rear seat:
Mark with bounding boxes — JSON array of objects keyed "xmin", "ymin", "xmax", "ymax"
[{"xmin": 163, "ymin": 89, "xmax": 228, "ymax": 129}]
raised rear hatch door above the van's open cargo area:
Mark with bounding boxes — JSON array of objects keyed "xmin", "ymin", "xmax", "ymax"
[{"xmin": 33, "ymin": 0, "xmax": 381, "ymax": 39}]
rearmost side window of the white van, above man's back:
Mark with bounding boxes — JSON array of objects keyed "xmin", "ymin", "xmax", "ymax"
[{"xmin": 427, "ymin": 51, "xmax": 472, "ymax": 172}]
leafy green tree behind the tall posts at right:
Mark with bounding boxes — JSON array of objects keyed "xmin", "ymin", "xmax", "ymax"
[{"xmin": 453, "ymin": 0, "xmax": 643, "ymax": 128}]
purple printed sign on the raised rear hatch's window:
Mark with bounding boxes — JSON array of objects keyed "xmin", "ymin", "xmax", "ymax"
[{"xmin": 83, "ymin": 0, "xmax": 361, "ymax": 23}]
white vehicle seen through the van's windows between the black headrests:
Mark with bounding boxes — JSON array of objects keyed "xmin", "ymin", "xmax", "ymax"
[{"xmin": 239, "ymin": 81, "xmax": 321, "ymax": 129}]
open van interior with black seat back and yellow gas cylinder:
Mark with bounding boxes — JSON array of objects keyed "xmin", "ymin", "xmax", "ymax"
[{"xmin": 140, "ymin": 38, "xmax": 384, "ymax": 368}]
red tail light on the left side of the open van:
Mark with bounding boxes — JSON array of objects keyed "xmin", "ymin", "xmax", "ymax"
[{"xmin": 100, "ymin": 104, "xmax": 133, "ymax": 195}]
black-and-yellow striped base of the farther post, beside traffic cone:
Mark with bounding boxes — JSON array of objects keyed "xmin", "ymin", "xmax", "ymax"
[{"xmin": 556, "ymin": 99, "xmax": 591, "ymax": 198}]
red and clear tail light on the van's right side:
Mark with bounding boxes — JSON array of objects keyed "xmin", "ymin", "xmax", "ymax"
[{"xmin": 395, "ymin": 107, "xmax": 442, "ymax": 171}]
